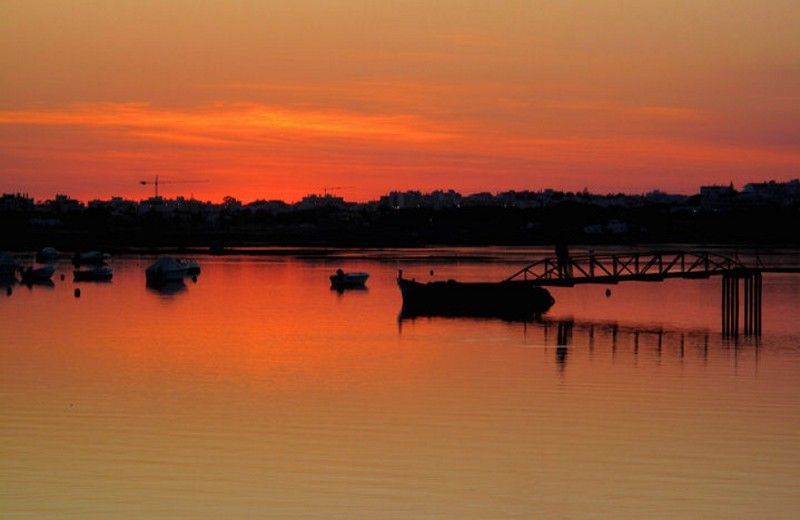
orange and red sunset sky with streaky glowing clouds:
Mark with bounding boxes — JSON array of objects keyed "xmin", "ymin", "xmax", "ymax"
[{"xmin": 0, "ymin": 0, "xmax": 800, "ymax": 200}]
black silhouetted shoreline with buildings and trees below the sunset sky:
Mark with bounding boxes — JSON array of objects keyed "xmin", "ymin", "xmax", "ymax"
[{"xmin": 0, "ymin": 179, "xmax": 800, "ymax": 252}]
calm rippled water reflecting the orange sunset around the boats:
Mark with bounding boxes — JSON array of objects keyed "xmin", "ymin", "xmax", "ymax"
[{"xmin": 0, "ymin": 250, "xmax": 800, "ymax": 519}]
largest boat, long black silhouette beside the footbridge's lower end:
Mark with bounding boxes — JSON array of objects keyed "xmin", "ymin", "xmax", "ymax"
[{"xmin": 397, "ymin": 271, "xmax": 555, "ymax": 319}]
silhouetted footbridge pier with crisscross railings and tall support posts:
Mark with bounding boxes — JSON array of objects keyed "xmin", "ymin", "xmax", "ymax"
[{"xmin": 504, "ymin": 251, "xmax": 800, "ymax": 336}]
